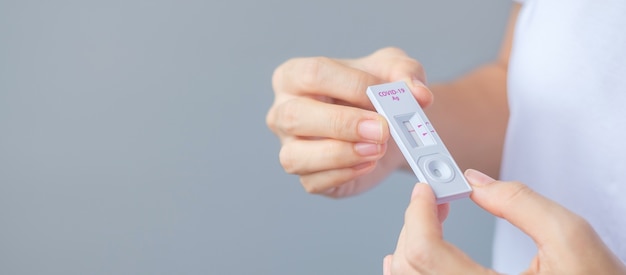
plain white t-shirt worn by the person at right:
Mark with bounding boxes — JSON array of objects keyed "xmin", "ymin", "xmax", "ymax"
[{"xmin": 493, "ymin": 0, "xmax": 626, "ymax": 274}]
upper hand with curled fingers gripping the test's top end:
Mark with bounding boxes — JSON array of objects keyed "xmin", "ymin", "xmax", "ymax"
[{"xmin": 266, "ymin": 48, "xmax": 432, "ymax": 197}]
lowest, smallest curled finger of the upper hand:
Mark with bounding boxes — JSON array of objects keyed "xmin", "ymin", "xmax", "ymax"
[{"xmin": 300, "ymin": 162, "xmax": 376, "ymax": 197}]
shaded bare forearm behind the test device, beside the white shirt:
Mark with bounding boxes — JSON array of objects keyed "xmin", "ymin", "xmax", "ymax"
[{"xmin": 404, "ymin": 62, "xmax": 508, "ymax": 177}]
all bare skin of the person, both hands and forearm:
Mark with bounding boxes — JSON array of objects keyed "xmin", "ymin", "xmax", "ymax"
[{"xmin": 266, "ymin": 4, "xmax": 626, "ymax": 275}]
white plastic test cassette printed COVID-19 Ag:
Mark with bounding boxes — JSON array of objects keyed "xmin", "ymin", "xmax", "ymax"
[{"xmin": 367, "ymin": 82, "xmax": 472, "ymax": 204}]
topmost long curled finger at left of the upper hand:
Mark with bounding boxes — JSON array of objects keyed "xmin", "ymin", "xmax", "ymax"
[{"xmin": 272, "ymin": 57, "xmax": 383, "ymax": 110}]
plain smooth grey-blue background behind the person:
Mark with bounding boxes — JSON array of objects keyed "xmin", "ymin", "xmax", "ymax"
[{"xmin": 0, "ymin": 0, "xmax": 511, "ymax": 274}]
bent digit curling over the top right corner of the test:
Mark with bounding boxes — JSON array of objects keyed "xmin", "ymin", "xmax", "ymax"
[{"xmin": 344, "ymin": 47, "xmax": 433, "ymax": 108}]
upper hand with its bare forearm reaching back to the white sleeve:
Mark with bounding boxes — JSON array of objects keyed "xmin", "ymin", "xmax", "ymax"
[{"xmin": 266, "ymin": 5, "xmax": 520, "ymax": 197}]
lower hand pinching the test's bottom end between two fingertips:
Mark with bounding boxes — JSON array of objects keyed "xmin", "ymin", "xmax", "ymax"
[{"xmin": 383, "ymin": 170, "xmax": 626, "ymax": 275}]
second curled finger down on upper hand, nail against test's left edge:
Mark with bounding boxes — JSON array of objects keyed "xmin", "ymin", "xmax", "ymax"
[{"xmin": 268, "ymin": 98, "xmax": 389, "ymax": 143}]
